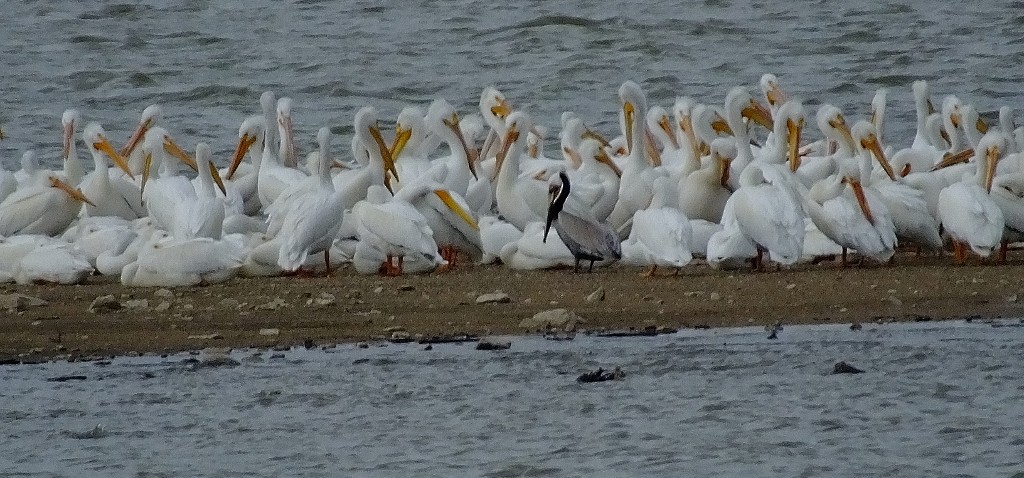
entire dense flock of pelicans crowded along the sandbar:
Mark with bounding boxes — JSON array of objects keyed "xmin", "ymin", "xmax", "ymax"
[{"xmin": 0, "ymin": 74, "xmax": 1024, "ymax": 287}]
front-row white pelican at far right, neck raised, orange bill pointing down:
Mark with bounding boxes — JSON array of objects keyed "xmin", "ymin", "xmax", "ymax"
[{"xmin": 938, "ymin": 132, "xmax": 1006, "ymax": 264}]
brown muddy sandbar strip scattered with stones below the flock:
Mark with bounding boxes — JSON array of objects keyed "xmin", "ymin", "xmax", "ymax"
[{"xmin": 0, "ymin": 256, "xmax": 1024, "ymax": 362}]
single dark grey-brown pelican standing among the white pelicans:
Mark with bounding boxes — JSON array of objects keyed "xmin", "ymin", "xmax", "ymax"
[{"xmin": 544, "ymin": 171, "xmax": 623, "ymax": 272}]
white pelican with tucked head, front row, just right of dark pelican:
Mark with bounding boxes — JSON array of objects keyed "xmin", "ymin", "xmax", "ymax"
[{"xmin": 622, "ymin": 177, "xmax": 693, "ymax": 276}]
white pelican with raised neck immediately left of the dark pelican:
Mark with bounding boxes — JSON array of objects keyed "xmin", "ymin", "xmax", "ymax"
[{"xmin": 495, "ymin": 112, "xmax": 548, "ymax": 230}]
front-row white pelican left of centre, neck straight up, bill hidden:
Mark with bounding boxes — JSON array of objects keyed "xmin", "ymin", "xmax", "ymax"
[{"xmin": 274, "ymin": 127, "xmax": 345, "ymax": 274}]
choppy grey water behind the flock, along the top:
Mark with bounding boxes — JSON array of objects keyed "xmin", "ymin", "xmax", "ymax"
[{"xmin": 0, "ymin": 0, "xmax": 1024, "ymax": 167}]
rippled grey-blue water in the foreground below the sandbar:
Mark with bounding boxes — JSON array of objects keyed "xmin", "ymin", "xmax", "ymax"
[{"xmin": 6, "ymin": 320, "xmax": 1024, "ymax": 477}]
